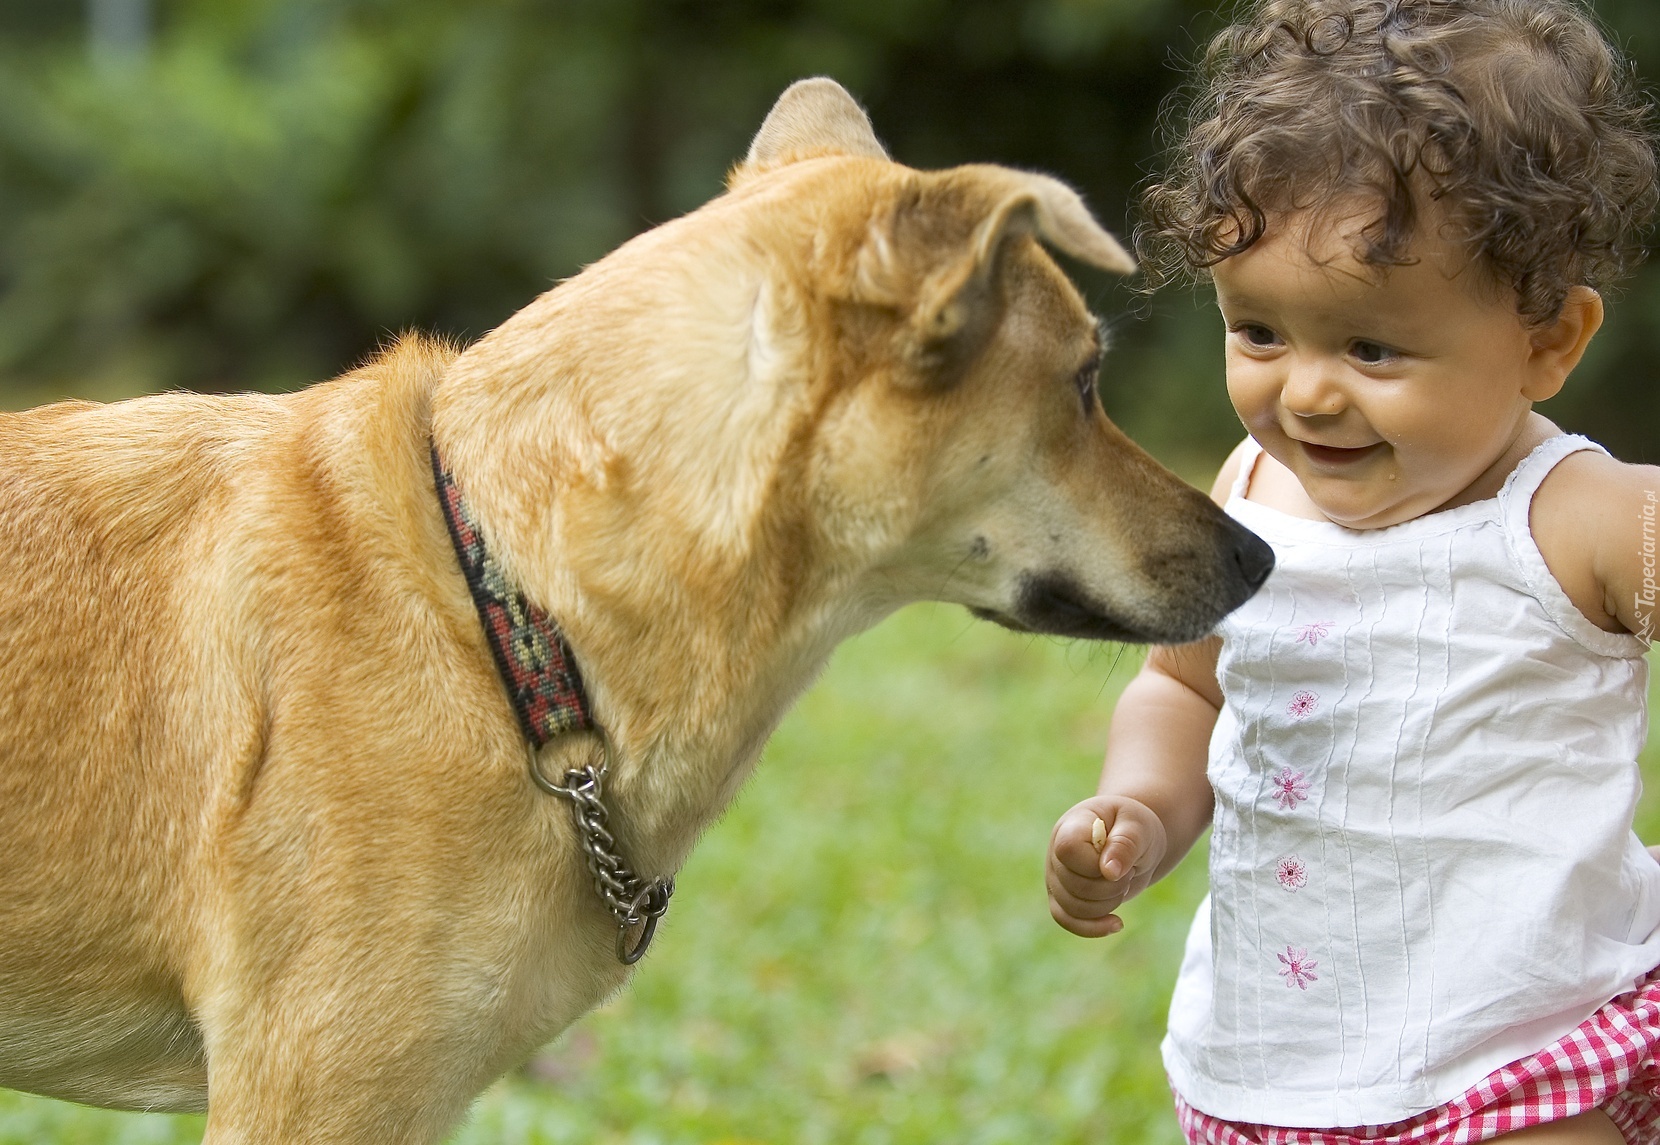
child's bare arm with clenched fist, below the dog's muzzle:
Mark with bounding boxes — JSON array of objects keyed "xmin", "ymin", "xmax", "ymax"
[{"xmin": 1044, "ymin": 450, "xmax": 1240, "ymax": 938}]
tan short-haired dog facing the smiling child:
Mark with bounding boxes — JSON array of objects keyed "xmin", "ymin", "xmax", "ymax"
[{"xmin": 0, "ymin": 80, "xmax": 1272, "ymax": 1145}]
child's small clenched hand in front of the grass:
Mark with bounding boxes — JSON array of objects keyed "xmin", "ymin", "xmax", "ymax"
[{"xmin": 1044, "ymin": 795, "xmax": 1165, "ymax": 938}]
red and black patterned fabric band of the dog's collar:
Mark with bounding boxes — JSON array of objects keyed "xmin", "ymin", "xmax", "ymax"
[{"xmin": 432, "ymin": 443, "xmax": 594, "ymax": 747}]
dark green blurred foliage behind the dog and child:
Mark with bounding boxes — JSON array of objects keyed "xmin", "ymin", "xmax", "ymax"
[{"xmin": 0, "ymin": 0, "xmax": 1660, "ymax": 466}]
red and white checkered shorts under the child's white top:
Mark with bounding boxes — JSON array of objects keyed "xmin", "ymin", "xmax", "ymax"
[{"xmin": 1175, "ymin": 969, "xmax": 1660, "ymax": 1145}]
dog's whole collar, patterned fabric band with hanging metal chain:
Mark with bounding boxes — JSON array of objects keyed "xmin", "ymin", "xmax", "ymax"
[{"xmin": 432, "ymin": 443, "xmax": 674, "ymax": 966}]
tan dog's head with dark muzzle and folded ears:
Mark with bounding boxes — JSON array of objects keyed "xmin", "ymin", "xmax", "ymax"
[{"xmin": 732, "ymin": 80, "xmax": 1273, "ymax": 641}]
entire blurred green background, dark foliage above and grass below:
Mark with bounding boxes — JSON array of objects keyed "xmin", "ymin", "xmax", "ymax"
[{"xmin": 0, "ymin": 0, "xmax": 1660, "ymax": 1145}]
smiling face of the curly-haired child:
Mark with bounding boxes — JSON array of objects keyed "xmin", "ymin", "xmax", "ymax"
[{"xmin": 1215, "ymin": 216, "xmax": 1577, "ymax": 528}]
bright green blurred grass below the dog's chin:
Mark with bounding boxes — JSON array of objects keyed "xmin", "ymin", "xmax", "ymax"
[{"xmin": 0, "ymin": 606, "xmax": 1660, "ymax": 1145}]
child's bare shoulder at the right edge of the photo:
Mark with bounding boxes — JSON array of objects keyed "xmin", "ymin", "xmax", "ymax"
[{"xmin": 1529, "ymin": 438, "xmax": 1660, "ymax": 636}]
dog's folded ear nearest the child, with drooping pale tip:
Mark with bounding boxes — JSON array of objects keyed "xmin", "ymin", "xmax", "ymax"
[{"xmin": 911, "ymin": 168, "xmax": 1135, "ymax": 383}]
